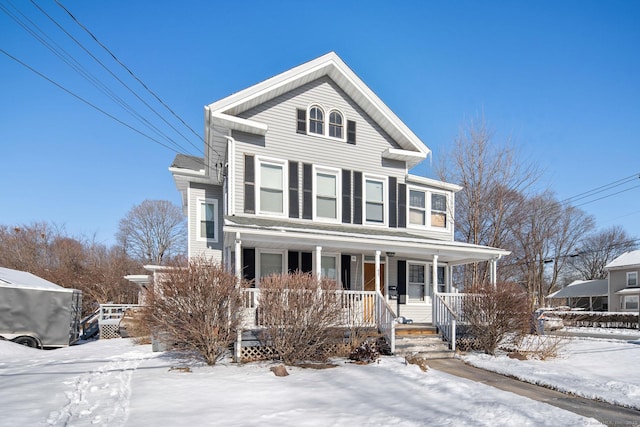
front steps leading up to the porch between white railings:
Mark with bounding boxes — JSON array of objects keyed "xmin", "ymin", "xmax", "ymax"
[{"xmin": 396, "ymin": 324, "xmax": 453, "ymax": 359}]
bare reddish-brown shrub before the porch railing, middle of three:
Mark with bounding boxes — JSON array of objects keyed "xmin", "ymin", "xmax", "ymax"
[{"xmin": 258, "ymin": 272, "xmax": 343, "ymax": 365}]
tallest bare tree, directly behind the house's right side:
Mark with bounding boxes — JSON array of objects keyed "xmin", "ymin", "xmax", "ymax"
[{"xmin": 438, "ymin": 117, "xmax": 539, "ymax": 287}]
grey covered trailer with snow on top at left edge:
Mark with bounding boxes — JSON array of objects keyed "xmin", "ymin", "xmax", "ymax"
[{"xmin": 0, "ymin": 267, "xmax": 82, "ymax": 348}]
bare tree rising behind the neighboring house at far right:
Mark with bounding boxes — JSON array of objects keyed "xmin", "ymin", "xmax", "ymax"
[{"xmin": 569, "ymin": 226, "xmax": 638, "ymax": 280}]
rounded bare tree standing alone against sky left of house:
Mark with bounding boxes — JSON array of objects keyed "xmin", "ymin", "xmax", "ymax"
[{"xmin": 116, "ymin": 200, "xmax": 187, "ymax": 265}]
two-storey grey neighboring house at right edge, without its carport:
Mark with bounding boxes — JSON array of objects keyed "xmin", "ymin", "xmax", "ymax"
[{"xmin": 605, "ymin": 250, "xmax": 640, "ymax": 311}]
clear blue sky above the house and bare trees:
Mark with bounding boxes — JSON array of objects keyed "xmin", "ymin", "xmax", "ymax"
[{"xmin": 0, "ymin": 0, "xmax": 640, "ymax": 244}]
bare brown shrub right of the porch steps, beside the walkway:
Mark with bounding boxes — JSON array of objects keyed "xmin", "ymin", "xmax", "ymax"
[{"xmin": 464, "ymin": 283, "xmax": 531, "ymax": 354}]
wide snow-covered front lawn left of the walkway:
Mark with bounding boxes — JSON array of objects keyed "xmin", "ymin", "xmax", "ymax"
[{"xmin": 0, "ymin": 339, "xmax": 604, "ymax": 427}]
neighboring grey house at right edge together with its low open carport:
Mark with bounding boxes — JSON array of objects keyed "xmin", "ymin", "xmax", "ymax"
[{"xmin": 547, "ymin": 250, "xmax": 640, "ymax": 312}]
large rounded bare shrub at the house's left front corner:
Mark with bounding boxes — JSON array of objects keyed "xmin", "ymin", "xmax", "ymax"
[{"xmin": 145, "ymin": 258, "xmax": 242, "ymax": 365}]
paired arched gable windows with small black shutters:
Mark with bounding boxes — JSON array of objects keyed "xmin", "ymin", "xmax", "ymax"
[{"xmin": 296, "ymin": 105, "xmax": 356, "ymax": 145}]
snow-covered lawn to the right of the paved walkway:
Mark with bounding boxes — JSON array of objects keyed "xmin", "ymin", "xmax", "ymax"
[{"xmin": 463, "ymin": 334, "xmax": 640, "ymax": 409}]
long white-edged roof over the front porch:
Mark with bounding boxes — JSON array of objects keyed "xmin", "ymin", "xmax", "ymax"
[{"xmin": 224, "ymin": 216, "xmax": 510, "ymax": 265}]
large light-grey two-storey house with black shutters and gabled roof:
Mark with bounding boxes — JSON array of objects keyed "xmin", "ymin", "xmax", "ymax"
[{"xmin": 169, "ymin": 52, "xmax": 508, "ymax": 323}]
